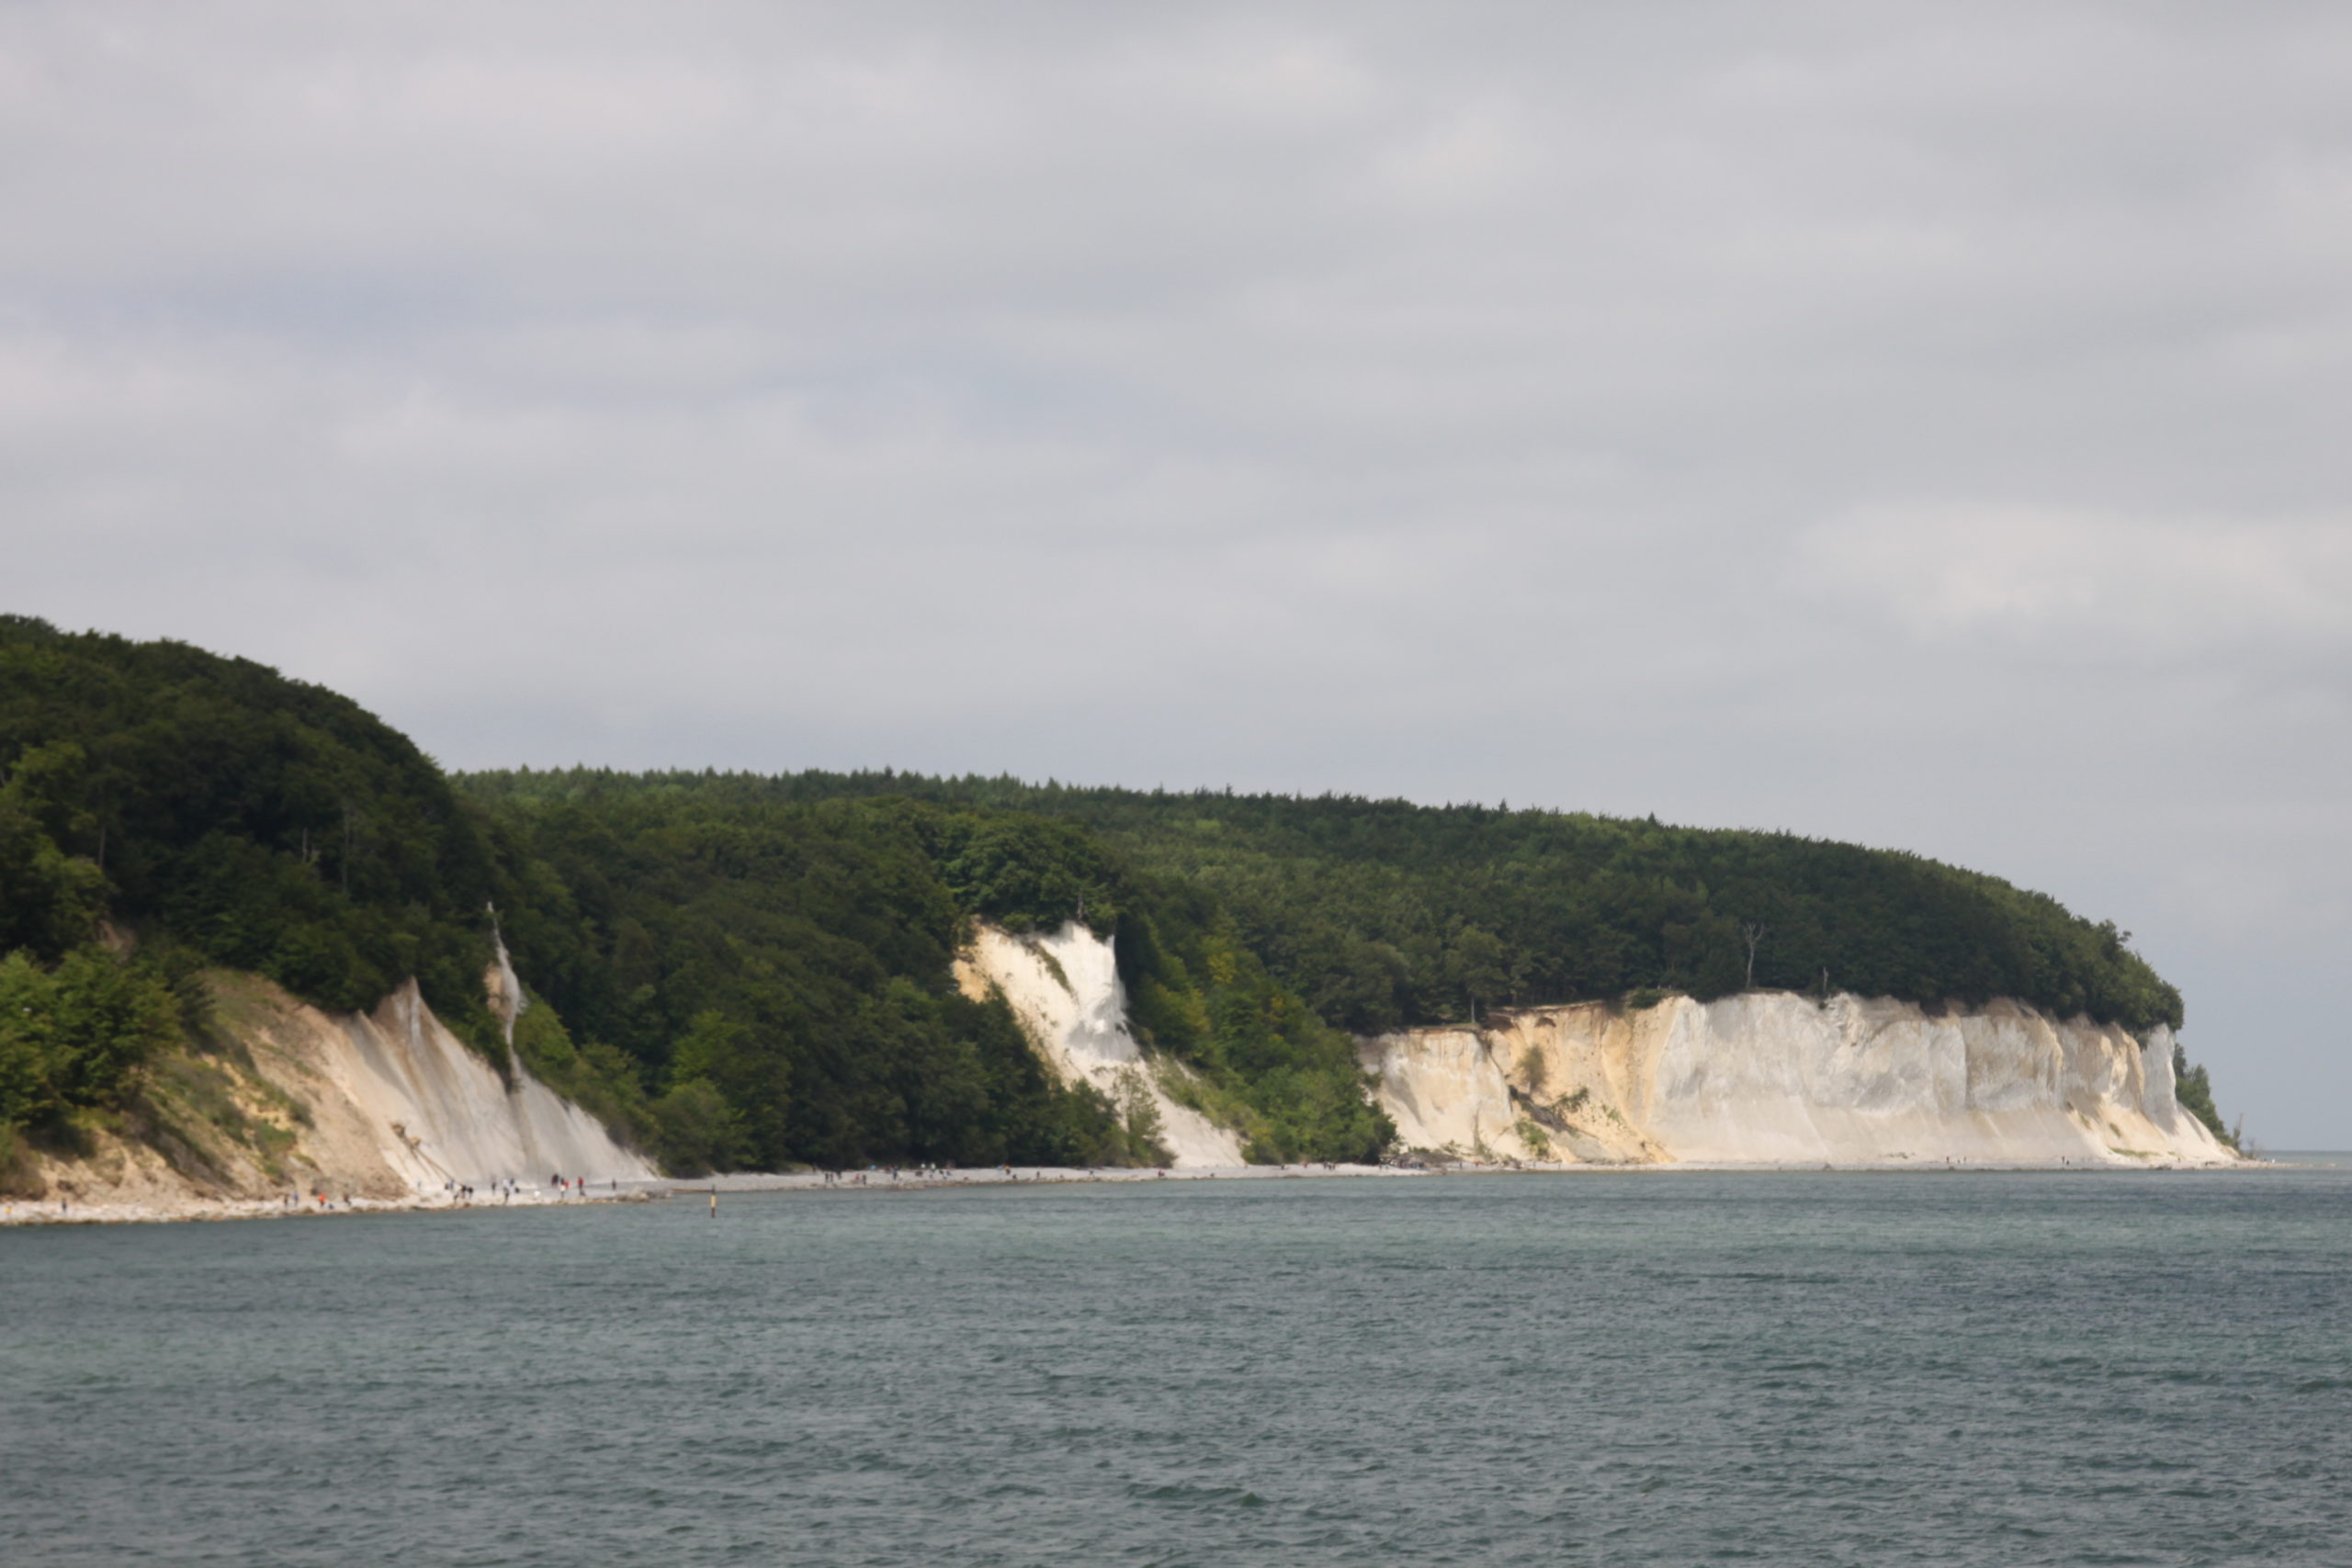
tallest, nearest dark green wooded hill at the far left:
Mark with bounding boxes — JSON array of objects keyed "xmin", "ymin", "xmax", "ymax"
[{"xmin": 0, "ymin": 616, "xmax": 499, "ymax": 1037}]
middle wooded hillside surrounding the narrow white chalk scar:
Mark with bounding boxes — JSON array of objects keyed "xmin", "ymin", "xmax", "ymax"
[{"xmin": 492, "ymin": 787, "xmax": 1385, "ymax": 1164}]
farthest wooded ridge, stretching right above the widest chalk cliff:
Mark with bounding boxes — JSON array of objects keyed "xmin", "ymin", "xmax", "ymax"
[{"xmin": 466, "ymin": 773, "xmax": 2180, "ymax": 1032}]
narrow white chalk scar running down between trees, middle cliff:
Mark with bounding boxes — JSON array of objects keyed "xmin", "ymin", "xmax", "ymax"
[{"xmin": 955, "ymin": 921, "xmax": 1242, "ymax": 1166}]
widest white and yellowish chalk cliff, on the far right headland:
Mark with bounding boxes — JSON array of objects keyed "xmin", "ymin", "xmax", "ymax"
[{"xmin": 1360, "ymin": 992, "xmax": 2234, "ymax": 1166}]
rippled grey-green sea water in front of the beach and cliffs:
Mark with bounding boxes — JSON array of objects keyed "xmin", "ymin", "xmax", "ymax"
[{"xmin": 0, "ymin": 1161, "xmax": 2352, "ymax": 1568}]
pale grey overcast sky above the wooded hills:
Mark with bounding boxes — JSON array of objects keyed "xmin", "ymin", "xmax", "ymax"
[{"xmin": 0, "ymin": 0, "xmax": 2352, "ymax": 1147}]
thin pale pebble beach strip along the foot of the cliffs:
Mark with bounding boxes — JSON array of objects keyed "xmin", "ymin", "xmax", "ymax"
[{"xmin": 0, "ymin": 1156, "xmax": 2277, "ymax": 1229}]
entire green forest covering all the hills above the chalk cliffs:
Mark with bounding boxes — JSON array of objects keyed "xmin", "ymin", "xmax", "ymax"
[{"xmin": 0, "ymin": 616, "xmax": 2218, "ymax": 1173}]
